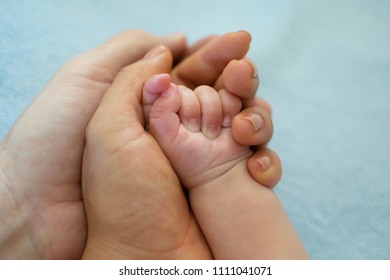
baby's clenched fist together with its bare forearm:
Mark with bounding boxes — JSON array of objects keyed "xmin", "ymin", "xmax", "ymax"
[{"xmin": 142, "ymin": 74, "xmax": 307, "ymax": 259}]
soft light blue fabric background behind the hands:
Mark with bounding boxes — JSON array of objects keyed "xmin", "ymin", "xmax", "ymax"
[{"xmin": 0, "ymin": 0, "xmax": 390, "ymax": 259}]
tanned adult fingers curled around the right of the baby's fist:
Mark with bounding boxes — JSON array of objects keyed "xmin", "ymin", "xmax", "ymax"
[{"xmin": 171, "ymin": 31, "xmax": 282, "ymax": 188}]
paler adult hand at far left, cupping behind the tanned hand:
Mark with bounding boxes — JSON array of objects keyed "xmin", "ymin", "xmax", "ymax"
[{"xmin": 0, "ymin": 31, "xmax": 186, "ymax": 259}]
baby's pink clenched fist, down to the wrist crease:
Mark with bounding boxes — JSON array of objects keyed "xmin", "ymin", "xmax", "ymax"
[{"xmin": 142, "ymin": 74, "xmax": 252, "ymax": 188}]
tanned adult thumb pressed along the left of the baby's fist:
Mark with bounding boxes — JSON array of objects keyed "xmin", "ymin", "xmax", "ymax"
[{"xmin": 87, "ymin": 45, "xmax": 172, "ymax": 140}]
